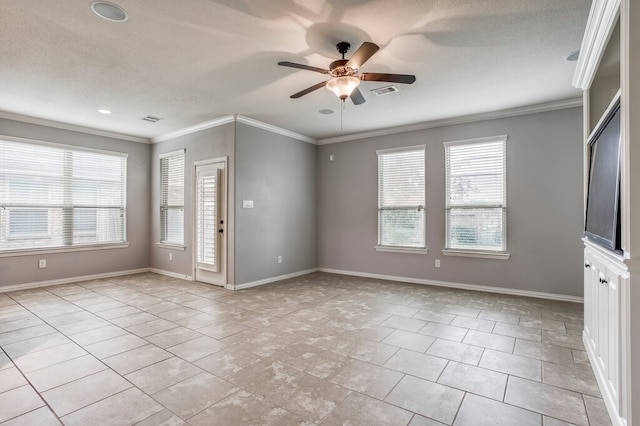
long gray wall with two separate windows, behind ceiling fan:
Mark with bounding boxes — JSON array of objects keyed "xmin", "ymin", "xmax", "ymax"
[{"xmin": 317, "ymin": 108, "xmax": 583, "ymax": 296}]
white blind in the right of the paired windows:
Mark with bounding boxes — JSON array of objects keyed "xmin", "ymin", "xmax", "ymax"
[{"xmin": 444, "ymin": 136, "xmax": 507, "ymax": 252}]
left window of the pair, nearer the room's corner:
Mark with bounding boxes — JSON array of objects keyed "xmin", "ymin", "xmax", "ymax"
[{"xmin": 377, "ymin": 145, "xmax": 426, "ymax": 249}]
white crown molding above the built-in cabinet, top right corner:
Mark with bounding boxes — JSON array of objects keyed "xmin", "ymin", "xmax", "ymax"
[{"xmin": 573, "ymin": 0, "xmax": 620, "ymax": 90}]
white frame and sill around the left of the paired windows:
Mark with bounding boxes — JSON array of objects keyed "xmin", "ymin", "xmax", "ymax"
[{"xmin": 374, "ymin": 144, "xmax": 429, "ymax": 254}]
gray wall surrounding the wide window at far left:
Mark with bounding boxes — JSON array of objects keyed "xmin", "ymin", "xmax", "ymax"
[{"xmin": 0, "ymin": 119, "xmax": 151, "ymax": 286}]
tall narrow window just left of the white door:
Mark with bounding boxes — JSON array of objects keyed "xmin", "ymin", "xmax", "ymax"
[{"xmin": 160, "ymin": 150, "xmax": 184, "ymax": 245}]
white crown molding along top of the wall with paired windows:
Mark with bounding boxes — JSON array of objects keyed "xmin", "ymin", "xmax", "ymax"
[{"xmin": 316, "ymin": 98, "xmax": 582, "ymax": 145}]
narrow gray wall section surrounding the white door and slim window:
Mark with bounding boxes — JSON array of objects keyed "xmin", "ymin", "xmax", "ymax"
[{"xmin": 149, "ymin": 123, "xmax": 235, "ymax": 283}]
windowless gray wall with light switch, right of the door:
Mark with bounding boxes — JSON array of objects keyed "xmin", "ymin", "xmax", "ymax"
[{"xmin": 235, "ymin": 123, "xmax": 317, "ymax": 284}]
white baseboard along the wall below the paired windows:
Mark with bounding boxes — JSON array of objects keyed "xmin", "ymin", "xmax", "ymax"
[{"xmin": 318, "ymin": 268, "xmax": 584, "ymax": 303}]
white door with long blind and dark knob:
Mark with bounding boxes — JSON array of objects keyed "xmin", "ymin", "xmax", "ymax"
[{"xmin": 194, "ymin": 159, "xmax": 227, "ymax": 286}]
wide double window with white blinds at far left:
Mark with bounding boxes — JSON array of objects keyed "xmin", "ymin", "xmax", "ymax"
[{"xmin": 0, "ymin": 139, "xmax": 127, "ymax": 251}]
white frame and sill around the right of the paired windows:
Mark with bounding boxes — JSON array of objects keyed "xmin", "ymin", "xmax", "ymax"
[{"xmin": 442, "ymin": 135, "xmax": 511, "ymax": 260}]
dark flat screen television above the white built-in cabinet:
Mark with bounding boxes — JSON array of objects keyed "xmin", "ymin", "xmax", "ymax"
[{"xmin": 585, "ymin": 95, "xmax": 622, "ymax": 252}]
